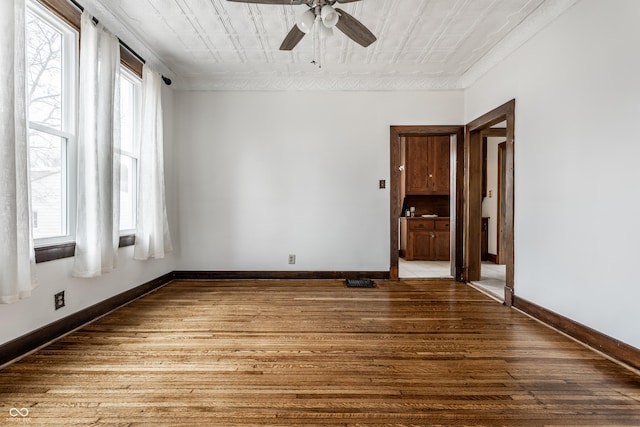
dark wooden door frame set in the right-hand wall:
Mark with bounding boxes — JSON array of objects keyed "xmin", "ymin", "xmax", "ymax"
[{"xmin": 463, "ymin": 100, "xmax": 515, "ymax": 306}]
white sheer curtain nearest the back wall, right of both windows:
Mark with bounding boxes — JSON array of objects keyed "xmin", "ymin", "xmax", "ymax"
[{"xmin": 133, "ymin": 65, "xmax": 172, "ymax": 260}]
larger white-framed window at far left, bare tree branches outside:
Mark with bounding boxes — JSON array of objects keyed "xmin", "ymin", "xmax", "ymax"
[{"xmin": 26, "ymin": 3, "xmax": 78, "ymax": 246}]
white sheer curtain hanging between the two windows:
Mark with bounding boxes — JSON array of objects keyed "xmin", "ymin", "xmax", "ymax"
[{"xmin": 73, "ymin": 11, "xmax": 120, "ymax": 277}]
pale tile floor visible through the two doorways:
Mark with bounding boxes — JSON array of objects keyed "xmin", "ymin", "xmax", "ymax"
[{"xmin": 399, "ymin": 258, "xmax": 506, "ymax": 301}]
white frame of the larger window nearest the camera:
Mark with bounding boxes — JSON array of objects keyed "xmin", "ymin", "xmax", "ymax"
[{"xmin": 27, "ymin": 0, "xmax": 79, "ymax": 247}]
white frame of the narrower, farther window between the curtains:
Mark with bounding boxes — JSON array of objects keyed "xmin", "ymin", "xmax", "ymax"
[{"xmin": 117, "ymin": 65, "xmax": 142, "ymax": 236}]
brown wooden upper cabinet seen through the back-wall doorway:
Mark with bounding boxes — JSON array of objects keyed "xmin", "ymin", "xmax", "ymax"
[{"xmin": 403, "ymin": 135, "xmax": 451, "ymax": 195}]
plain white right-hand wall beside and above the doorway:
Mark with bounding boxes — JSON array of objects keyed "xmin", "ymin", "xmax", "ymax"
[{"xmin": 465, "ymin": 0, "xmax": 640, "ymax": 347}]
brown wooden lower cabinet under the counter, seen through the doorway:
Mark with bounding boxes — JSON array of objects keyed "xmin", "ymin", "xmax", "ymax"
[{"xmin": 400, "ymin": 218, "xmax": 450, "ymax": 261}]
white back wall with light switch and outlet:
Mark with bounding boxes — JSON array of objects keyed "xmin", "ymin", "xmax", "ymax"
[{"xmin": 176, "ymin": 91, "xmax": 463, "ymax": 271}]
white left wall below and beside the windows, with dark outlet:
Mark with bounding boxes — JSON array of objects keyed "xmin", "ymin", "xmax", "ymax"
[{"xmin": 0, "ymin": 88, "xmax": 176, "ymax": 344}]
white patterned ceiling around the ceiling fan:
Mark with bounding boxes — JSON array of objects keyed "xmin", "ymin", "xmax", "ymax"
[{"xmin": 86, "ymin": 0, "xmax": 576, "ymax": 89}]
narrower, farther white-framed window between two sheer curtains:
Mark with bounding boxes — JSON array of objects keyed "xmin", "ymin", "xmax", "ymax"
[{"xmin": 120, "ymin": 67, "xmax": 141, "ymax": 234}]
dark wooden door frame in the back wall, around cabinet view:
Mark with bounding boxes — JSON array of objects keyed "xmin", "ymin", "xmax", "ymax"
[{"xmin": 389, "ymin": 126, "xmax": 464, "ymax": 280}]
